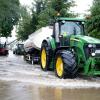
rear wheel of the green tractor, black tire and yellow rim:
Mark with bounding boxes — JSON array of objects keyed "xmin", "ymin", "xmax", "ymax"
[{"xmin": 40, "ymin": 42, "xmax": 51, "ymax": 71}]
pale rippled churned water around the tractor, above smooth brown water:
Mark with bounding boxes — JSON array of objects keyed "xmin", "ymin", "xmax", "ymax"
[{"xmin": 0, "ymin": 51, "xmax": 100, "ymax": 88}]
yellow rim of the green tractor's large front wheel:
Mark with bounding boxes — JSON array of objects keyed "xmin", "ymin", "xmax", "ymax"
[{"xmin": 56, "ymin": 57, "xmax": 64, "ymax": 77}]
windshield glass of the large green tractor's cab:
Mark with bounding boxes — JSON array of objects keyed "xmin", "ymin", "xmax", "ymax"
[{"xmin": 60, "ymin": 21, "xmax": 83, "ymax": 35}]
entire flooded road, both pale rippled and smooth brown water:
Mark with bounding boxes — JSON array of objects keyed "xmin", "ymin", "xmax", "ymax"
[{"xmin": 0, "ymin": 51, "xmax": 100, "ymax": 100}]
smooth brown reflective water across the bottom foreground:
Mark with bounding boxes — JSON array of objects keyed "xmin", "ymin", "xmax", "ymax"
[{"xmin": 0, "ymin": 81, "xmax": 100, "ymax": 100}]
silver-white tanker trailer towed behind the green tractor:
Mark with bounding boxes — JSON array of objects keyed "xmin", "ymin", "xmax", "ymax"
[{"xmin": 24, "ymin": 26, "xmax": 53, "ymax": 64}]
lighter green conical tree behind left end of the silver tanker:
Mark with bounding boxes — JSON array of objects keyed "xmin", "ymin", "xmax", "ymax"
[{"xmin": 16, "ymin": 6, "xmax": 33, "ymax": 40}]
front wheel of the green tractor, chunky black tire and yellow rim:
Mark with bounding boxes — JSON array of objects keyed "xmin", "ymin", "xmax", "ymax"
[{"xmin": 55, "ymin": 50, "xmax": 77, "ymax": 78}]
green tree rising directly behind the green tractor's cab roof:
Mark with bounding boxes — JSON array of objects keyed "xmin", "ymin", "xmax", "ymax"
[{"xmin": 37, "ymin": 0, "xmax": 74, "ymax": 29}]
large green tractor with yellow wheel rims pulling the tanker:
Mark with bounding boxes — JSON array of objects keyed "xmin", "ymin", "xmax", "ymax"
[{"xmin": 41, "ymin": 18, "xmax": 100, "ymax": 78}]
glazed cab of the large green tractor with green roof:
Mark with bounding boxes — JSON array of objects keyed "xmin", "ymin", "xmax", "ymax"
[{"xmin": 53, "ymin": 18, "xmax": 85, "ymax": 45}]
